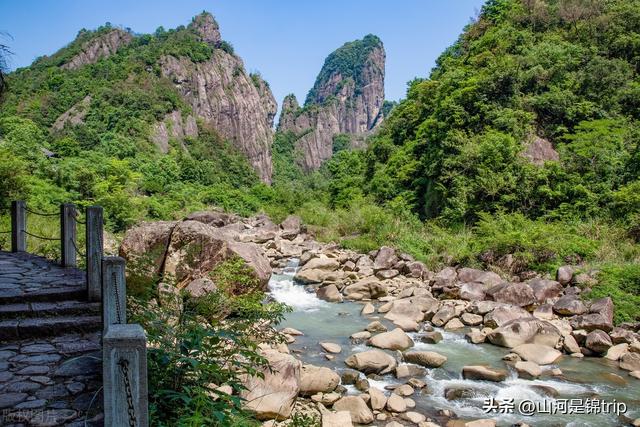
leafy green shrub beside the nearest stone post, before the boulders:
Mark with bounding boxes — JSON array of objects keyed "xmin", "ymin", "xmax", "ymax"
[{"xmin": 130, "ymin": 259, "xmax": 287, "ymax": 426}]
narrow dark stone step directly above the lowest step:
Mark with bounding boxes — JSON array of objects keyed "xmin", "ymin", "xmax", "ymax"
[{"xmin": 0, "ymin": 300, "xmax": 101, "ymax": 319}]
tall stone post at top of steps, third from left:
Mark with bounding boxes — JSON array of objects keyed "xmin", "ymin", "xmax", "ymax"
[{"xmin": 85, "ymin": 206, "xmax": 103, "ymax": 301}]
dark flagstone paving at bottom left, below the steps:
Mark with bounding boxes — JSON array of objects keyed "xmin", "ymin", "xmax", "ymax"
[{"xmin": 0, "ymin": 333, "xmax": 103, "ymax": 427}]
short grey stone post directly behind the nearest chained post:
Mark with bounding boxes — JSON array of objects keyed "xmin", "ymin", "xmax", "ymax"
[{"xmin": 102, "ymin": 256, "xmax": 127, "ymax": 334}]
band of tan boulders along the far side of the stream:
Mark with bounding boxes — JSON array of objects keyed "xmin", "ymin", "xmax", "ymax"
[{"xmin": 288, "ymin": 247, "xmax": 640, "ymax": 377}]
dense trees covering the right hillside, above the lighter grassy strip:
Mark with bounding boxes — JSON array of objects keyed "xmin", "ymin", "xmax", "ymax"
[{"xmin": 366, "ymin": 0, "xmax": 640, "ymax": 224}]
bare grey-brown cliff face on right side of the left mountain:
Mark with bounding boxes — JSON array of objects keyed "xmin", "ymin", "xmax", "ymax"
[{"xmin": 159, "ymin": 14, "xmax": 277, "ymax": 183}]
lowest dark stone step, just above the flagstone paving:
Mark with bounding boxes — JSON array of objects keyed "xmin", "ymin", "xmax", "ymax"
[{"xmin": 0, "ymin": 315, "xmax": 102, "ymax": 341}]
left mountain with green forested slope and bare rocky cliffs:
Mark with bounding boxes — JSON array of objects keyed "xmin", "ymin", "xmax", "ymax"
[{"xmin": 0, "ymin": 13, "xmax": 276, "ymax": 234}]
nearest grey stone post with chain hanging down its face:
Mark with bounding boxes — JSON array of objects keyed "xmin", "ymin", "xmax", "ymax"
[{"xmin": 102, "ymin": 324, "xmax": 149, "ymax": 427}]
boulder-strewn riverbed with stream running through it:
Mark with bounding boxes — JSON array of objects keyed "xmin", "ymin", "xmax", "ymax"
[{"xmin": 120, "ymin": 212, "xmax": 640, "ymax": 427}]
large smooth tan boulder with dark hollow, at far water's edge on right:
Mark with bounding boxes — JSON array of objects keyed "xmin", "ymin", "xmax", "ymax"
[{"xmin": 487, "ymin": 317, "xmax": 562, "ymax": 348}]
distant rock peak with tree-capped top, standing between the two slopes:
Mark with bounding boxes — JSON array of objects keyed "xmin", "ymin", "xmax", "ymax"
[{"xmin": 278, "ymin": 35, "xmax": 385, "ymax": 170}]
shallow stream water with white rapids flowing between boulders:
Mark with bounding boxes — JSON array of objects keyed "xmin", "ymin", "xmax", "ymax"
[{"xmin": 269, "ymin": 259, "xmax": 640, "ymax": 427}]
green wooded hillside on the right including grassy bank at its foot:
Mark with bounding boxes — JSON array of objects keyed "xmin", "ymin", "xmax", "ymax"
[{"xmin": 268, "ymin": 0, "xmax": 640, "ymax": 321}]
